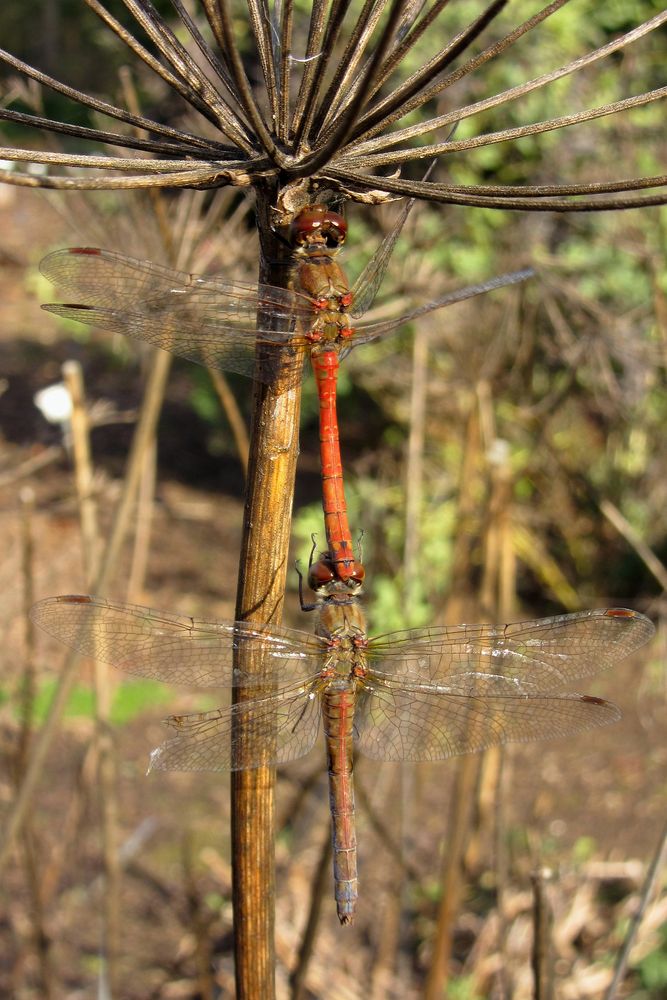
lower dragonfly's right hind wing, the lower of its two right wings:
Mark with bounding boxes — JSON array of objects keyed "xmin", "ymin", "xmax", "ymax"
[{"xmin": 355, "ymin": 679, "xmax": 621, "ymax": 761}]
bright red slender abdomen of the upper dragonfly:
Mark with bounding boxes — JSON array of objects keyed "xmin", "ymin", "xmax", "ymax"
[{"xmin": 311, "ymin": 351, "xmax": 354, "ymax": 580}]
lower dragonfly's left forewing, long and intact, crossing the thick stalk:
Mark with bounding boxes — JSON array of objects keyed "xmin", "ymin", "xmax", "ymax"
[{"xmin": 30, "ymin": 595, "xmax": 326, "ymax": 687}]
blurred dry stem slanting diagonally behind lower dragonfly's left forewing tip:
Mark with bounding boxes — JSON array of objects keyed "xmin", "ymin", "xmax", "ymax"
[{"xmin": 0, "ymin": 351, "xmax": 171, "ymax": 871}]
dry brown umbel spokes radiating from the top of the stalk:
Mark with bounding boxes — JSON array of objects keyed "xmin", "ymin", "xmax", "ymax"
[{"xmin": 0, "ymin": 0, "xmax": 667, "ymax": 212}]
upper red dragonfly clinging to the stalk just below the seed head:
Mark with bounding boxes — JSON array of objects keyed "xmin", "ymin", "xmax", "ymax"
[{"xmin": 40, "ymin": 199, "xmax": 533, "ymax": 580}]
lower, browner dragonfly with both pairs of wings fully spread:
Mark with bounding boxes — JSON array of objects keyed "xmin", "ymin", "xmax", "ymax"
[{"xmin": 31, "ymin": 553, "xmax": 654, "ymax": 924}]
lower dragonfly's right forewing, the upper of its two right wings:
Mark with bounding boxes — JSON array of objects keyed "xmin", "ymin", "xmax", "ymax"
[{"xmin": 368, "ymin": 608, "xmax": 655, "ymax": 694}]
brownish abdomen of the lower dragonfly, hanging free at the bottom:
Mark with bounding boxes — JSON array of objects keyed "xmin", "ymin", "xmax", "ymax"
[{"xmin": 322, "ymin": 688, "xmax": 358, "ymax": 924}]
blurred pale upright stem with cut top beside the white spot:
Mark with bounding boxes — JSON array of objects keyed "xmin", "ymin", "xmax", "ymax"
[{"xmin": 62, "ymin": 361, "xmax": 120, "ymax": 996}]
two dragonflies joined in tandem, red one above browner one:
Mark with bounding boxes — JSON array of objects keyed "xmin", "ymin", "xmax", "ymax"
[{"xmin": 32, "ymin": 204, "xmax": 654, "ymax": 924}]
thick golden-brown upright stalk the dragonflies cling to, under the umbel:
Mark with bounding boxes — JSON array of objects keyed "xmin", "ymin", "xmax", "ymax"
[{"xmin": 231, "ymin": 191, "xmax": 301, "ymax": 1000}]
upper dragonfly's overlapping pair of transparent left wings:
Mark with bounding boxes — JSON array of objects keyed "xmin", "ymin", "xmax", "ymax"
[{"xmin": 40, "ymin": 247, "xmax": 312, "ymax": 381}]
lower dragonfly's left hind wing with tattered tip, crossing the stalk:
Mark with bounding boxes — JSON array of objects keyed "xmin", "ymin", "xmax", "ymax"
[{"xmin": 151, "ymin": 689, "xmax": 320, "ymax": 771}]
